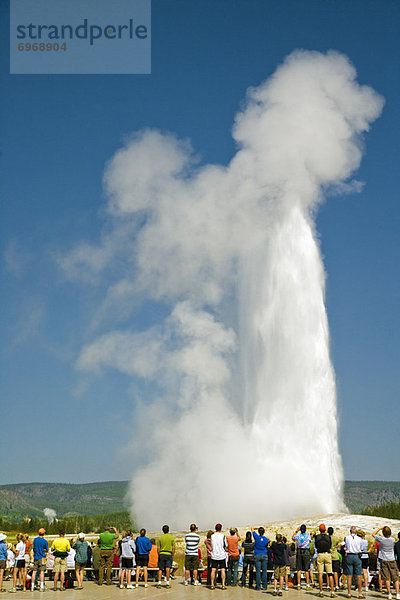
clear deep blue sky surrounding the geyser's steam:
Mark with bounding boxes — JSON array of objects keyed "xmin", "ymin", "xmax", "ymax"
[{"xmin": 0, "ymin": 0, "xmax": 400, "ymax": 483}]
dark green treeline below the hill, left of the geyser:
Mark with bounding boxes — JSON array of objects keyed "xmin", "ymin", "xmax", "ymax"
[{"xmin": 0, "ymin": 510, "xmax": 137, "ymax": 535}]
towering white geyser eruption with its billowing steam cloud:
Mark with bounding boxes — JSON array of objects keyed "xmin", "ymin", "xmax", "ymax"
[{"xmin": 63, "ymin": 51, "xmax": 383, "ymax": 528}]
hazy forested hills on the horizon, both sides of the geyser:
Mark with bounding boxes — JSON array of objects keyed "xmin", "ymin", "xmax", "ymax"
[{"xmin": 0, "ymin": 481, "xmax": 400, "ymax": 520}]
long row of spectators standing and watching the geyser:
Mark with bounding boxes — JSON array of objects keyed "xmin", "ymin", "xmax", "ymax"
[{"xmin": 0, "ymin": 523, "xmax": 400, "ymax": 600}]
